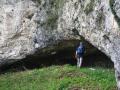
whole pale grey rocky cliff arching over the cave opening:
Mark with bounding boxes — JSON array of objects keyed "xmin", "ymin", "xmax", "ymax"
[{"xmin": 0, "ymin": 0, "xmax": 120, "ymax": 88}]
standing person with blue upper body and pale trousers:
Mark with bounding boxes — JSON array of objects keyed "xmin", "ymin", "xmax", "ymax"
[{"xmin": 76, "ymin": 42, "xmax": 85, "ymax": 67}]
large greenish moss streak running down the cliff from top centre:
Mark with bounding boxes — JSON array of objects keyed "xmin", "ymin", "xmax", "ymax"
[{"xmin": 46, "ymin": 0, "xmax": 65, "ymax": 29}]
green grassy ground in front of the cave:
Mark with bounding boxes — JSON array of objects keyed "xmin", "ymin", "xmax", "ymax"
[{"xmin": 0, "ymin": 65, "xmax": 116, "ymax": 90}]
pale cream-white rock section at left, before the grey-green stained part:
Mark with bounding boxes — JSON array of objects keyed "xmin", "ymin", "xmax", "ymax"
[{"xmin": 0, "ymin": 0, "xmax": 37, "ymax": 65}]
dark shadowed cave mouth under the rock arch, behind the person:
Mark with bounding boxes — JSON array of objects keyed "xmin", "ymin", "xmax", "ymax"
[{"xmin": 0, "ymin": 40, "xmax": 113, "ymax": 73}]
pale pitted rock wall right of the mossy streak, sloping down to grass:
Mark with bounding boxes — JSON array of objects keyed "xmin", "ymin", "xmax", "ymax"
[{"xmin": 59, "ymin": 0, "xmax": 120, "ymax": 88}]
